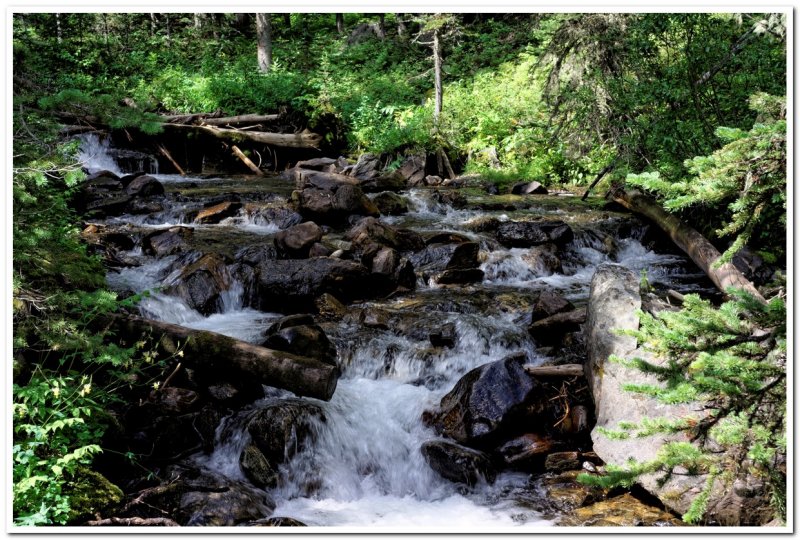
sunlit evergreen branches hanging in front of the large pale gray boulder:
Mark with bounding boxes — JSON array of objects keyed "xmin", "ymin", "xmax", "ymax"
[{"xmin": 582, "ymin": 290, "xmax": 786, "ymax": 523}]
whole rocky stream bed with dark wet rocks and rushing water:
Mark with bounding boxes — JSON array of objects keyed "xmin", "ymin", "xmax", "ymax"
[{"xmin": 72, "ymin": 134, "xmax": 740, "ymax": 532}]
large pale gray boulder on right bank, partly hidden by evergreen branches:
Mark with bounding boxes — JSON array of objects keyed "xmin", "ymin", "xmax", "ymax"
[{"xmin": 585, "ymin": 264, "xmax": 768, "ymax": 525}]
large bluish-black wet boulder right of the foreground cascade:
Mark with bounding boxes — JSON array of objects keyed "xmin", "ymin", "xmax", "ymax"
[{"xmin": 434, "ymin": 354, "xmax": 542, "ymax": 447}]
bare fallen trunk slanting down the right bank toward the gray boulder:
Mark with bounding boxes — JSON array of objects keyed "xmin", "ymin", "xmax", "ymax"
[{"xmin": 610, "ymin": 189, "xmax": 765, "ymax": 302}]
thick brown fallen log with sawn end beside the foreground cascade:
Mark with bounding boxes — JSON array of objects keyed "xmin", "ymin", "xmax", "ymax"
[{"xmin": 111, "ymin": 316, "xmax": 339, "ymax": 401}]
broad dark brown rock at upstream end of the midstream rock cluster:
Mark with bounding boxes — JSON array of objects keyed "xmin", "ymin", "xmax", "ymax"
[{"xmin": 292, "ymin": 185, "xmax": 380, "ymax": 224}]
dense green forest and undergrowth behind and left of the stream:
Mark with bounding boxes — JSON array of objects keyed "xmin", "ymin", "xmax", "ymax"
[{"xmin": 12, "ymin": 13, "xmax": 787, "ymax": 524}]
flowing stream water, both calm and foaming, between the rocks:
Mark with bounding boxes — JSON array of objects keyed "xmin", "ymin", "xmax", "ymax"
[{"xmin": 78, "ymin": 134, "xmax": 713, "ymax": 532}]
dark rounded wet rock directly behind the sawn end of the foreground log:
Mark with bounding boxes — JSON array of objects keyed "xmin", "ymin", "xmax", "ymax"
[{"xmin": 263, "ymin": 315, "xmax": 336, "ymax": 366}]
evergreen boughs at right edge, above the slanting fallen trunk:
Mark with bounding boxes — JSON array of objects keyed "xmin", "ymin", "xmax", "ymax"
[{"xmin": 627, "ymin": 93, "xmax": 786, "ymax": 263}]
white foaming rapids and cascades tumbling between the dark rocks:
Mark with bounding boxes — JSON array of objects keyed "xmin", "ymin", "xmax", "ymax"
[{"xmin": 83, "ymin": 138, "xmax": 712, "ymax": 532}]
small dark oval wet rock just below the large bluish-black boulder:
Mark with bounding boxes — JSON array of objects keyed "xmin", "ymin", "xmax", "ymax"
[{"xmin": 420, "ymin": 440, "xmax": 497, "ymax": 486}]
